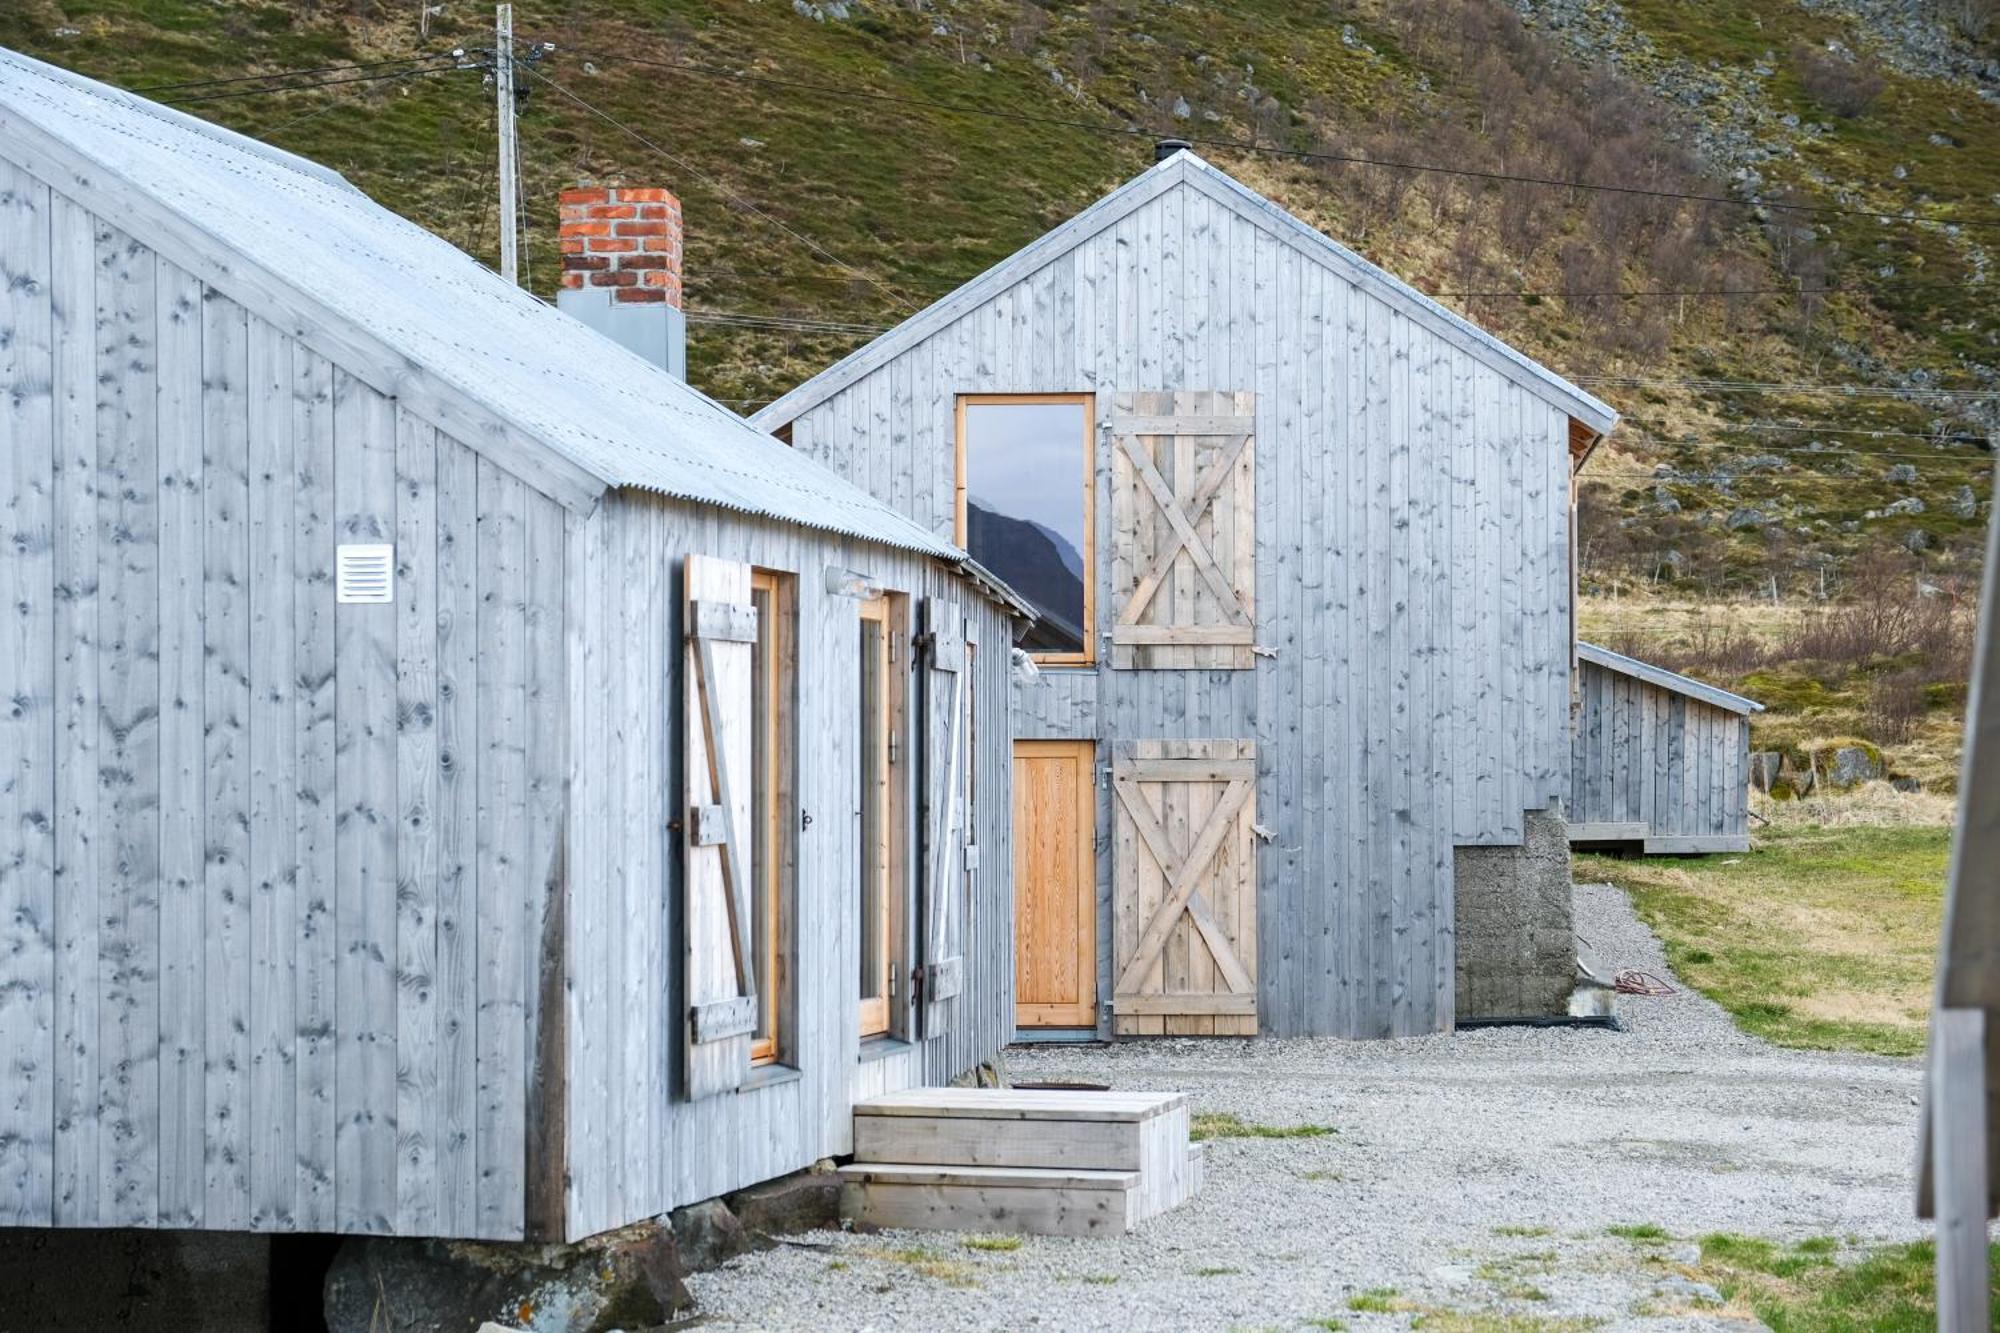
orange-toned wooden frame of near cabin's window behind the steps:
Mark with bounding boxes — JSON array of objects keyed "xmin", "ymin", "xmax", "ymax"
[{"xmin": 854, "ymin": 592, "xmax": 910, "ymax": 1041}]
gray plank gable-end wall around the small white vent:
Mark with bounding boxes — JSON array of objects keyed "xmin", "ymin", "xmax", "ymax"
[{"xmin": 0, "ymin": 162, "xmax": 566, "ymax": 1237}]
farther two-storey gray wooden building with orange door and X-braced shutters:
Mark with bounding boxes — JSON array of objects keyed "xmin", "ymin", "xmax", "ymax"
[{"xmin": 754, "ymin": 152, "xmax": 1616, "ymax": 1037}]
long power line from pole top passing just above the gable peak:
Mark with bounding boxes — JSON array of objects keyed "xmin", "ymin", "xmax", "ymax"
[{"xmin": 564, "ymin": 47, "xmax": 2000, "ymax": 226}]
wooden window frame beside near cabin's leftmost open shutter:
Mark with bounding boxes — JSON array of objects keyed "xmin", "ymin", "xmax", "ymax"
[{"xmin": 750, "ymin": 568, "xmax": 798, "ymax": 1067}]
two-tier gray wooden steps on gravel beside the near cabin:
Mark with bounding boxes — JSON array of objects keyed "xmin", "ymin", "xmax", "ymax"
[{"xmin": 840, "ymin": 1087, "xmax": 1202, "ymax": 1235}]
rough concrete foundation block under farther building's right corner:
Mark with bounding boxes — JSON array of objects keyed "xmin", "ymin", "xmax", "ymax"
[{"xmin": 1454, "ymin": 807, "xmax": 1576, "ymax": 1023}]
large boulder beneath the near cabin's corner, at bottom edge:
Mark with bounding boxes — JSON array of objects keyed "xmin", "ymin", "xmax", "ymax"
[{"xmin": 326, "ymin": 1221, "xmax": 694, "ymax": 1333}]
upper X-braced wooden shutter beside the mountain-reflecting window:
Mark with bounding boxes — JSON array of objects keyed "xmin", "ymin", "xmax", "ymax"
[{"xmin": 1110, "ymin": 392, "xmax": 1256, "ymax": 671}]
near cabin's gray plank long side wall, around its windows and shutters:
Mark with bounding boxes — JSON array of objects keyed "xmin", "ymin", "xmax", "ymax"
[{"xmin": 564, "ymin": 492, "xmax": 1014, "ymax": 1237}]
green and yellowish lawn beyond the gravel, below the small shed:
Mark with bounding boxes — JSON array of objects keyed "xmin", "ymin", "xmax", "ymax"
[{"xmin": 1576, "ymin": 825, "xmax": 1950, "ymax": 1055}]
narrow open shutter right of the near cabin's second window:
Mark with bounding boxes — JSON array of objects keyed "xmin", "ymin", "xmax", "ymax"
[{"xmin": 922, "ymin": 596, "xmax": 972, "ymax": 1037}]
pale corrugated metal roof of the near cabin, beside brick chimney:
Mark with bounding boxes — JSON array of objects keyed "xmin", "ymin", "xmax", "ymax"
[{"xmin": 0, "ymin": 50, "xmax": 964, "ymax": 560}]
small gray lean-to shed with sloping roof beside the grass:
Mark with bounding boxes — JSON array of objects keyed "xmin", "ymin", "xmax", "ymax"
[{"xmin": 1568, "ymin": 642, "xmax": 1764, "ymax": 855}]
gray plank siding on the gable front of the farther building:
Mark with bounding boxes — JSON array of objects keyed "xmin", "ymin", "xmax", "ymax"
[{"xmin": 792, "ymin": 171, "xmax": 1570, "ymax": 1037}]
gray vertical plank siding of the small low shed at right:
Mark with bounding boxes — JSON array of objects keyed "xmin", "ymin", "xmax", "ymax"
[{"xmin": 1568, "ymin": 662, "xmax": 1750, "ymax": 851}]
